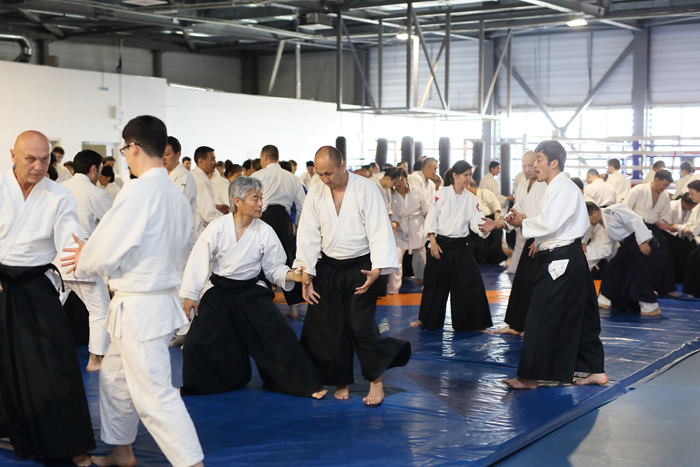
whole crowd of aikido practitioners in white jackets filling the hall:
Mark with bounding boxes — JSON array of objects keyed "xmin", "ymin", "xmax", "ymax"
[{"xmin": 0, "ymin": 116, "xmax": 700, "ymax": 467}]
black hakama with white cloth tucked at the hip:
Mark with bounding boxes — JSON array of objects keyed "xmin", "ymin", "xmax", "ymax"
[{"xmin": 518, "ymin": 239, "xmax": 605, "ymax": 383}]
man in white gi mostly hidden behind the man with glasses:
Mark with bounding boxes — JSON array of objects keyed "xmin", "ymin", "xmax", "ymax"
[{"xmin": 163, "ymin": 136, "xmax": 199, "ymax": 347}]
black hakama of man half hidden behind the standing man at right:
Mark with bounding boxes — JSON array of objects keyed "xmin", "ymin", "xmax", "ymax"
[{"xmin": 505, "ymin": 238, "xmax": 540, "ymax": 332}]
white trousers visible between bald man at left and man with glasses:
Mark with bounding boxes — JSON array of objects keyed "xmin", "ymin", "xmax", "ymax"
[{"xmin": 61, "ymin": 277, "xmax": 110, "ymax": 355}]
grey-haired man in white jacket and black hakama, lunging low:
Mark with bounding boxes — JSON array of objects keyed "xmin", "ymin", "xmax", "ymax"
[{"xmin": 180, "ymin": 177, "xmax": 326, "ymax": 399}]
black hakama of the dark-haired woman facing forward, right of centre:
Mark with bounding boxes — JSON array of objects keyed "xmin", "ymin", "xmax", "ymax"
[{"xmin": 418, "ymin": 235, "xmax": 493, "ymax": 332}]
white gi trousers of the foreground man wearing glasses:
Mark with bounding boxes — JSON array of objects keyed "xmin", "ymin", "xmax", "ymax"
[{"xmin": 100, "ymin": 302, "xmax": 204, "ymax": 467}]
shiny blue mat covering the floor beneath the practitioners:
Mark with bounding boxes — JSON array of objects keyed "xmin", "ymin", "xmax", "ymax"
[{"xmin": 0, "ymin": 267, "xmax": 700, "ymax": 467}]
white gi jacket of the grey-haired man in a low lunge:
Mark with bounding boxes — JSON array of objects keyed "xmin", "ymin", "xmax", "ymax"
[{"xmin": 180, "ymin": 214, "xmax": 294, "ymax": 301}]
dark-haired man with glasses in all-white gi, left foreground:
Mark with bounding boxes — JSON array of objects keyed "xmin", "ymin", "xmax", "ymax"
[{"xmin": 63, "ymin": 116, "xmax": 204, "ymax": 467}]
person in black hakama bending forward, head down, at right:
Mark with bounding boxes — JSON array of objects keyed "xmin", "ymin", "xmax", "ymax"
[{"xmin": 586, "ymin": 203, "xmax": 661, "ymax": 316}]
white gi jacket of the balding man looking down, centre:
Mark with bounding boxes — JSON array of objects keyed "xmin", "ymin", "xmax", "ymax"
[{"xmin": 293, "ymin": 173, "xmax": 399, "ymax": 276}]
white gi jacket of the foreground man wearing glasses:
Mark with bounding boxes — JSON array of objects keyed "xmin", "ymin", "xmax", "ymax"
[{"xmin": 75, "ymin": 167, "xmax": 192, "ymax": 342}]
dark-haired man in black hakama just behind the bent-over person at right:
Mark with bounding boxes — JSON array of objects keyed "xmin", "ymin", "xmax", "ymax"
[{"xmin": 624, "ymin": 171, "xmax": 679, "ymax": 297}]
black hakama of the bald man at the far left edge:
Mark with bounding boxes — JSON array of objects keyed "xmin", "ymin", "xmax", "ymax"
[{"xmin": 0, "ymin": 264, "xmax": 95, "ymax": 460}]
